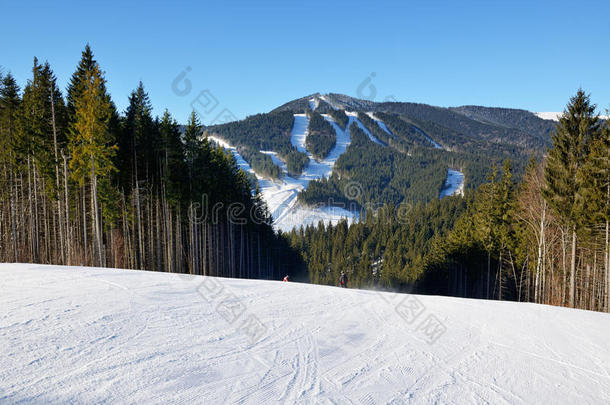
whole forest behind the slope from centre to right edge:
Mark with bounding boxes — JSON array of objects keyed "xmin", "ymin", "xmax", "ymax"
[{"xmin": 287, "ymin": 90, "xmax": 610, "ymax": 311}]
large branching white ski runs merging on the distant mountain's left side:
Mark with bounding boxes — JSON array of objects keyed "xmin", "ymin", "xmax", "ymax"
[{"xmin": 210, "ymin": 114, "xmax": 359, "ymax": 232}]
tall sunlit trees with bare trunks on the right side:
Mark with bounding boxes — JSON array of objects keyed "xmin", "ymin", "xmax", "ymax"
[{"xmin": 426, "ymin": 90, "xmax": 610, "ymax": 311}]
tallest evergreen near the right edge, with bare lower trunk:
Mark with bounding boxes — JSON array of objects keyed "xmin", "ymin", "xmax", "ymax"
[{"xmin": 543, "ymin": 89, "xmax": 601, "ymax": 307}]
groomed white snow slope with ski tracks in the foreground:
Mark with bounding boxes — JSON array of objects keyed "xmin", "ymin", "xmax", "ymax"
[{"xmin": 0, "ymin": 264, "xmax": 610, "ymax": 405}]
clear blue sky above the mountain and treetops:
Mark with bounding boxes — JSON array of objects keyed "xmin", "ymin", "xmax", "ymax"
[{"xmin": 0, "ymin": 0, "xmax": 610, "ymax": 123}]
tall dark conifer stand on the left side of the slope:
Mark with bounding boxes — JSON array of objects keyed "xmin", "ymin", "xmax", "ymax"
[{"xmin": 0, "ymin": 46, "xmax": 295, "ymax": 278}]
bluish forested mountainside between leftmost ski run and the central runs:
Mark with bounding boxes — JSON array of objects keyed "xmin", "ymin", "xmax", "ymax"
[{"xmin": 206, "ymin": 111, "xmax": 309, "ymax": 178}]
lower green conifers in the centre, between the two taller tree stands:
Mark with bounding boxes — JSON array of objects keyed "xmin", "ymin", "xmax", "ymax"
[{"xmin": 286, "ymin": 197, "xmax": 466, "ymax": 291}]
